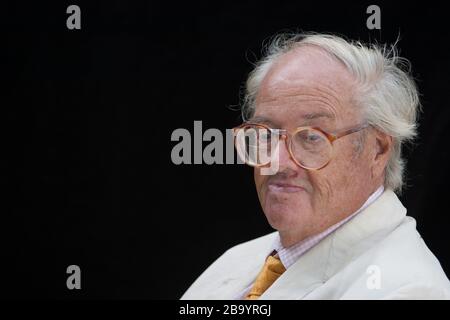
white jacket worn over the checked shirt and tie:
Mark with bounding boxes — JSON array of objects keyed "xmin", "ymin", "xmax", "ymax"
[{"xmin": 181, "ymin": 189, "xmax": 450, "ymax": 299}]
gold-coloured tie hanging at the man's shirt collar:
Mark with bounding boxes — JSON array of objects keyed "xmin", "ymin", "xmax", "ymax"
[{"xmin": 245, "ymin": 254, "xmax": 286, "ymax": 300}]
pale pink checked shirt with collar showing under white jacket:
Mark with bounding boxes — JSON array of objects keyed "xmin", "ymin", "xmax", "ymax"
[{"xmin": 236, "ymin": 185, "xmax": 384, "ymax": 299}]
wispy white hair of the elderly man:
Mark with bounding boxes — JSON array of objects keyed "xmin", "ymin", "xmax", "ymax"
[{"xmin": 242, "ymin": 33, "xmax": 420, "ymax": 193}]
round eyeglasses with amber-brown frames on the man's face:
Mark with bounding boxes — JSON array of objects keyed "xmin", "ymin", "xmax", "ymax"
[{"xmin": 233, "ymin": 122, "xmax": 369, "ymax": 170}]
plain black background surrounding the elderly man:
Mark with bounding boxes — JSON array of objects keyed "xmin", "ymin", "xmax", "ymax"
[{"xmin": 0, "ymin": 1, "xmax": 450, "ymax": 299}]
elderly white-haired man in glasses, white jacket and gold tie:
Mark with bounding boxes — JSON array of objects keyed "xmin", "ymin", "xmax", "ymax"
[{"xmin": 182, "ymin": 34, "xmax": 450, "ymax": 299}]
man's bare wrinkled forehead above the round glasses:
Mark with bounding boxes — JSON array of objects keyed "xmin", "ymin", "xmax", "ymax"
[{"xmin": 255, "ymin": 46, "xmax": 357, "ymax": 129}]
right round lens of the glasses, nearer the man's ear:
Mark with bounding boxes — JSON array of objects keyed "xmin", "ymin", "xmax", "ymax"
[{"xmin": 291, "ymin": 129, "xmax": 332, "ymax": 169}]
